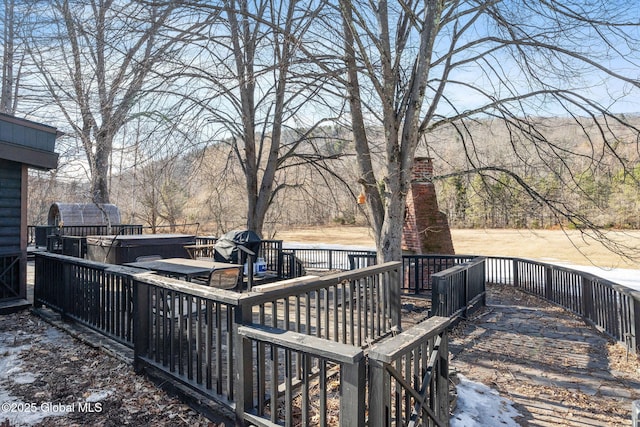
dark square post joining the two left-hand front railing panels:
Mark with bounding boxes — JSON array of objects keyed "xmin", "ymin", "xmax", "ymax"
[{"xmin": 133, "ymin": 279, "xmax": 151, "ymax": 373}]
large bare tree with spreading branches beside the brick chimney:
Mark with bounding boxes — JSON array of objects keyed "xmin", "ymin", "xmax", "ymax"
[{"xmin": 325, "ymin": 0, "xmax": 640, "ymax": 260}]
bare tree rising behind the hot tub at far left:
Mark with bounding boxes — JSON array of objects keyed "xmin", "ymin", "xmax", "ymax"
[{"xmin": 22, "ymin": 0, "xmax": 195, "ymax": 203}]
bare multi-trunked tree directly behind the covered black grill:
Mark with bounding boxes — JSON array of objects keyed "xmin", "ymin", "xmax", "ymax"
[{"xmin": 172, "ymin": 0, "xmax": 340, "ymax": 234}]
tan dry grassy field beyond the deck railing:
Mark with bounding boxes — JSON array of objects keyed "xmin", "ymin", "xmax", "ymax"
[{"xmin": 275, "ymin": 227, "xmax": 640, "ymax": 269}]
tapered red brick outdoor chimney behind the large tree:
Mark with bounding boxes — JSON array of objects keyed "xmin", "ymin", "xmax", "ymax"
[{"xmin": 402, "ymin": 157, "xmax": 455, "ymax": 255}]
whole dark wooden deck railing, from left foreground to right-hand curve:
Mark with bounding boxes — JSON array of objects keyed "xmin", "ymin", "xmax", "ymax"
[{"xmin": 35, "ymin": 249, "xmax": 640, "ymax": 425}]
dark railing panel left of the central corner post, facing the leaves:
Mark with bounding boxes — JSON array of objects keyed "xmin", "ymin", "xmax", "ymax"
[{"xmin": 134, "ymin": 275, "xmax": 239, "ymax": 405}]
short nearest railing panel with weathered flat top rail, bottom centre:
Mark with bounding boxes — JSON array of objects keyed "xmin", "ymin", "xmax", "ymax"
[{"xmin": 236, "ymin": 326, "xmax": 367, "ymax": 427}]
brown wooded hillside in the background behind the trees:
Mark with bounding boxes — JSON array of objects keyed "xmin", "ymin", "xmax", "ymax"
[{"xmin": 29, "ymin": 116, "xmax": 640, "ymax": 234}]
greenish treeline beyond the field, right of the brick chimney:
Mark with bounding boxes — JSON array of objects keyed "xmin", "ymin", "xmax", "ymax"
[{"xmin": 436, "ymin": 165, "xmax": 640, "ymax": 229}]
